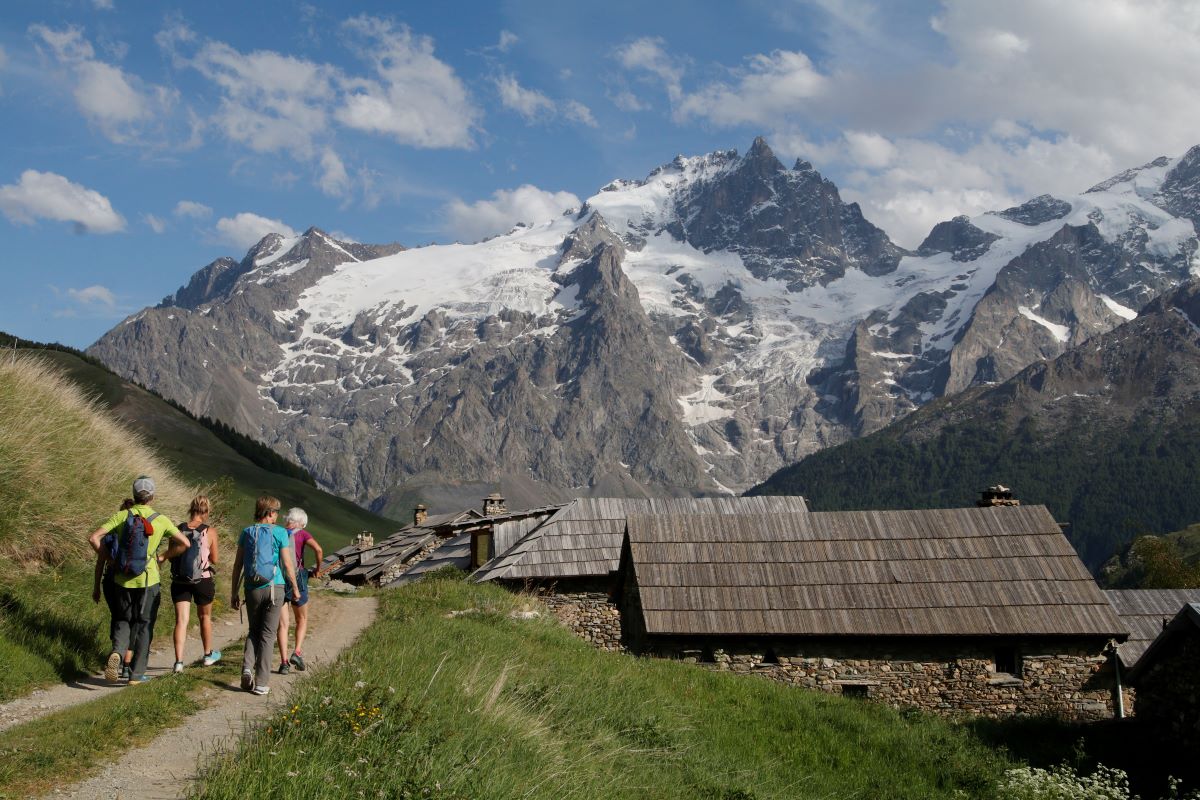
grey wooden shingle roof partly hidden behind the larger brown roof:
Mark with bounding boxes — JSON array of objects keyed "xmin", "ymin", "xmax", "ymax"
[{"xmin": 474, "ymin": 497, "xmax": 808, "ymax": 581}]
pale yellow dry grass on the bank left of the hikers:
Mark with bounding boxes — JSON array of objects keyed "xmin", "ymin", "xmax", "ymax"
[{"xmin": 0, "ymin": 355, "xmax": 194, "ymax": 572}]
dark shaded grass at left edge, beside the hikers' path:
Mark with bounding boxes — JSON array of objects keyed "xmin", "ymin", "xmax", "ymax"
[{"xmin": 0, "ymin": 589, "xmax": 102, "ymax": 680}]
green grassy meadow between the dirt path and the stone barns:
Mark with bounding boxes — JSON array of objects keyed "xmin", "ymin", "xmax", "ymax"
[{"xmin": 196, "ymin": 576, "xmax": 1008, "ymax": 800}]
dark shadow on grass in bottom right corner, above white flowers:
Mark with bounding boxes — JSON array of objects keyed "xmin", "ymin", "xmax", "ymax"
[{"xmin": 967, "ymin": 717, "xmax": 1200, "ymax": 798}]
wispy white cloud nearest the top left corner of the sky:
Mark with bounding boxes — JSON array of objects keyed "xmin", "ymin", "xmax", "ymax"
[{"xmin": 29, "ymin": 25, "xmax": 178, "ymax": 143}]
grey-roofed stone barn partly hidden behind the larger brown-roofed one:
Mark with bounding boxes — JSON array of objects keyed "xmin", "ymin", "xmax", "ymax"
[{"xmin": 473, "ymin": 497, "xmax": 808, "ymax": 650}]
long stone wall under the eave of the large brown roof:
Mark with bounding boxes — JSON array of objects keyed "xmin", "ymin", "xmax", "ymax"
[{"xmin": 648, "ymin": 637, "xmax": 1112, "ymax": 720}]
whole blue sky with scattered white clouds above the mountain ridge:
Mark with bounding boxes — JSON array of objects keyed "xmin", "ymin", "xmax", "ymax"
[{"xmin": 0, "ymin": 0, "xmax": 1200, "ymax": 347}]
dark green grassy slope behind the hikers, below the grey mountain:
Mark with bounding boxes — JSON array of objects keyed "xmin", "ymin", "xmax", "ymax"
[{"xmin": 23, "ymin": 350, "xmax": 403, "ymax": 552}]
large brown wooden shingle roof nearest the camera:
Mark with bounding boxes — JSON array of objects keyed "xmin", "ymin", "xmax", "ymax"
[{"xmin": 626, "ymin": 506, "xmax": 1124, "ymax": 636}]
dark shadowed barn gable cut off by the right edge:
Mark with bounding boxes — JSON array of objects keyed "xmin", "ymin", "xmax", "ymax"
[{"xmin": 1129, "ymin": 603, "xmax": 1200, "ymax": 754}]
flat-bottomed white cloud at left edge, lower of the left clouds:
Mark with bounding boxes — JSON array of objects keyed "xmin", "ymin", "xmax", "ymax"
[{"xmin": 0, "ymin": 169, "xmax": 125, "ymax": 234}]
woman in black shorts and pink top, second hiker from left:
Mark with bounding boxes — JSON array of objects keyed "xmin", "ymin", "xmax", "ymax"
[{"xmin": 170, "ymin": 494, "xmax": 221, "ymax": 672}]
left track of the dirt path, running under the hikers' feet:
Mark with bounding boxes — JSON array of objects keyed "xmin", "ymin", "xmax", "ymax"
[{"xmin": 0, "ymin": 599, "xmax": 253, "ymax": 730}]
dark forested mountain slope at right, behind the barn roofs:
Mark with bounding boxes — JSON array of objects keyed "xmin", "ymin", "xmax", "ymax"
[{"xmin": 750, "ymin": 282, "xmax": 1200, "ymax": 570}]
